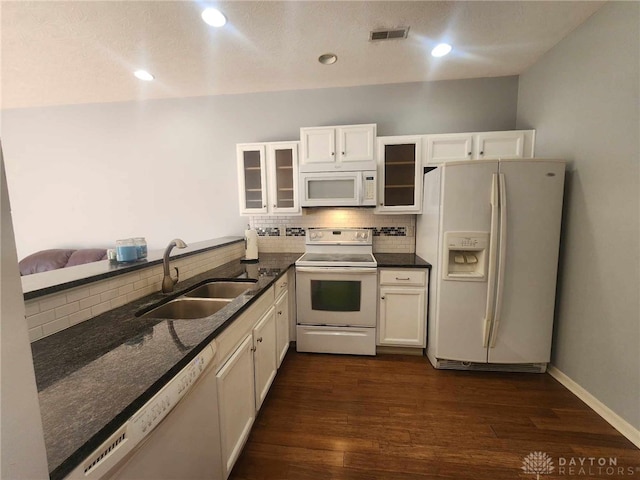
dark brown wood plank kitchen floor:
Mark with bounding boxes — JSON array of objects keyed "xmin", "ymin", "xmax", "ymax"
[{"xmin": 230, "ymin": 351, "xmax": 640, "ymax": 480}]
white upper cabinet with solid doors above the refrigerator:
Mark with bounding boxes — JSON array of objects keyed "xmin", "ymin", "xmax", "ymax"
[{"xmin": 425, "ymin": 130, "xmax": 535, "ymax": 165}]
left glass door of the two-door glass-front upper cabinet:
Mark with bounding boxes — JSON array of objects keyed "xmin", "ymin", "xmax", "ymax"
[{"xmin": 237, "ymin": 143, "xmax": 268, "ymax": 215}]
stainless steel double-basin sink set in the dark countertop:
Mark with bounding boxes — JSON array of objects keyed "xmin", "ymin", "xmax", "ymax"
[{"xmin": 136, "ymin": 279, "xmax": 257, "ymax": 320}]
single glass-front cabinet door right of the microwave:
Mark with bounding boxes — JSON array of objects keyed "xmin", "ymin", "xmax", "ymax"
[{"xmin": 376, "ymin": 136, "xmax": 423, "ymax": 213}]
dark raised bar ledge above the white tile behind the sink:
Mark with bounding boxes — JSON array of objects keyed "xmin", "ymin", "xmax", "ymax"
[{"xmin": 24, "ymin": 237, "xmax": 244, "ymax": 300}]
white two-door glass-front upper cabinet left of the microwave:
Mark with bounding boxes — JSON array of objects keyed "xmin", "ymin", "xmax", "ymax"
[{"xmin": 236, "ymin": 142, "xmax": 300, "ymax": 215}]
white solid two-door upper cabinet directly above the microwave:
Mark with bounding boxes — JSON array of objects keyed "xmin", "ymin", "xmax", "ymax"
[{"xmin": 300, "ymin": 124, "xmax": 376, "ymax": 172}]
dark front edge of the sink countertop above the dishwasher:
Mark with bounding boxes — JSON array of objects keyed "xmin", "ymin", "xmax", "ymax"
[{"xmin": 49, "ymin": 262, "xmax": 294, "ymax": 480}]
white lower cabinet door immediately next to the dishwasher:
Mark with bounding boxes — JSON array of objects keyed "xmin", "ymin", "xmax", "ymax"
[{"xmin": 216, "ymin": 334, "xmax": 256, "ymax": 478}]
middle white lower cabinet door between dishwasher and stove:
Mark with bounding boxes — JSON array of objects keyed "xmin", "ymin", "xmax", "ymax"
[{"xmin": 253, "ymin": 307, "xmax": 278, "ymax": 411}]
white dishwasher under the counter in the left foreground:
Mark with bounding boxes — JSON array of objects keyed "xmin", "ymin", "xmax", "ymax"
[{"xmin": 66, "ymin": 342, "xmax": 222, "ymax": 480}]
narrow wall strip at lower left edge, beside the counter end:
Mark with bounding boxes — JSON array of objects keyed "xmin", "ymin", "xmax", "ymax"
[{"xmin": 0, "ymin": 145, "xmax": 49, "ymax": 479}]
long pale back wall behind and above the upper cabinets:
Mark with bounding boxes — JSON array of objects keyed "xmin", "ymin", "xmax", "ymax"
[{"xmin": 2, "ymin": 77, "xmax": 518, "ymax": 258}]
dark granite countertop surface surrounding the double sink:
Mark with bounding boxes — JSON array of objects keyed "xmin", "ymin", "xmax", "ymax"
[{"xmin": 31, "ymin": 253, "xmax": 300, "ymax": 480}]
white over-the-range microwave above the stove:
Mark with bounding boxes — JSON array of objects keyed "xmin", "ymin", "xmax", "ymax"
[{"xmin": 300, "ymin": 170, "xmax": 376, "ymax": 207}]
